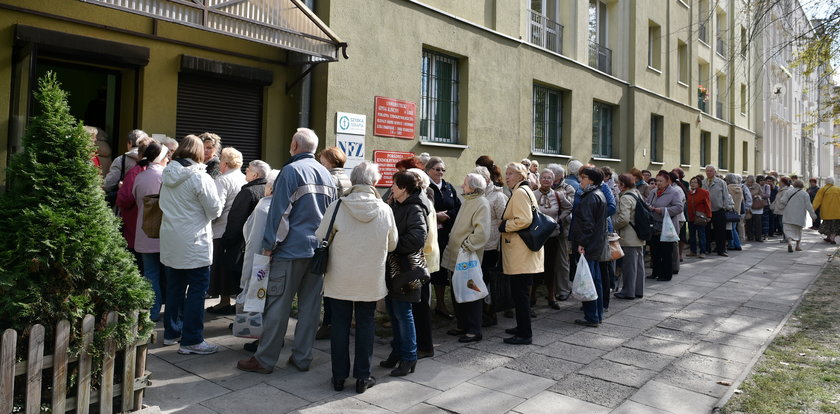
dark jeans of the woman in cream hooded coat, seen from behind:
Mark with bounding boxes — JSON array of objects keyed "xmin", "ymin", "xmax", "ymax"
[{"xmin": 324, "ymin": 298, "xmax": 376, "ymax": 380}]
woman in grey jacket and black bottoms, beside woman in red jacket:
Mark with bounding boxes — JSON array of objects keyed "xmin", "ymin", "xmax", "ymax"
[{"xmin": 647, "ymin": 170, "xmax": 684, "ymax": 281}]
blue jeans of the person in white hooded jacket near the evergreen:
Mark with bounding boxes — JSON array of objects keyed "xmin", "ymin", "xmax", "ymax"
[{"xmin": 163, "ymin": 266, "xmax": 210, "ymax": 346}]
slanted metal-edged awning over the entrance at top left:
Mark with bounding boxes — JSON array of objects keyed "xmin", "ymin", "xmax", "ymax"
[{"xmin": 80, "ymin": 0, "xmax": 347, "ymax": 62}]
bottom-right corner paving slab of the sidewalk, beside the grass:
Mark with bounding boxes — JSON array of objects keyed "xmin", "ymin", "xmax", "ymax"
[{"xmin": 630, "ymin": 381, "xmax": 717, "ymax": 414}]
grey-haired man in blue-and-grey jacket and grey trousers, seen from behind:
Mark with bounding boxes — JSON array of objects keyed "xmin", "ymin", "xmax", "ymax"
[{"xmin": 236, "ymin": 128, "xmax": 336, "ymax": 374}]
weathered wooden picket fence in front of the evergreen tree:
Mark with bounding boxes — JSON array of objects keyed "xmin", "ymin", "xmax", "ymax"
[{"xmin": 0, "ymin": 311, "xmax": 150, "ymax": 414}]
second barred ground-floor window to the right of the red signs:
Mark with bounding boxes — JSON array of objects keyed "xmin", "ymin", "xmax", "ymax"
[{"xmin": 531, "ymin": 85, "xmax": 563, "ymax": 154}]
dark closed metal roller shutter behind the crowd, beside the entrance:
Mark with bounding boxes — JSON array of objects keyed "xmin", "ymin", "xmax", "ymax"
[{"xmin": 175, "ymin": 73, "xmax": 263, "ymax": 167}]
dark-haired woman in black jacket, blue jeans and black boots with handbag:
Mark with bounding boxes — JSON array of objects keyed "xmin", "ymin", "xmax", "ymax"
[{"xmin": 384, "ymin": 171, "xmax": 429, "ymax": 377}]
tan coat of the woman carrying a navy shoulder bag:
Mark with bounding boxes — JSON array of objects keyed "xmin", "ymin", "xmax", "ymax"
[{"xmin": 501, "ymin": 184, "xmax": 545, "ymax": 275}]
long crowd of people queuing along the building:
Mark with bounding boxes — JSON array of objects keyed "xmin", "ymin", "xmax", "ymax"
[{"xmin": 93, "ymin": 128, "xmax": 840, "ymax": 393}]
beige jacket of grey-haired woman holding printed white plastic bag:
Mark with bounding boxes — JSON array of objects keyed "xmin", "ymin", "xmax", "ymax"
[{"xmin": 440, "ymin": 193, "xmax": 490, "ymax": 270}]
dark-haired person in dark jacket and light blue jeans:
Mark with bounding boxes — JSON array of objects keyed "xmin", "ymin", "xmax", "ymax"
[{"xmin": 569, "ymin": 168, "xmax": 609, "ymax": 327}]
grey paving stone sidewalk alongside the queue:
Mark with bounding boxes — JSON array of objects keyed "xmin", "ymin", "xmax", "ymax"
[{"xmin": 145, "ymin": 230, "xmax": 836, "ymax": 414}]
